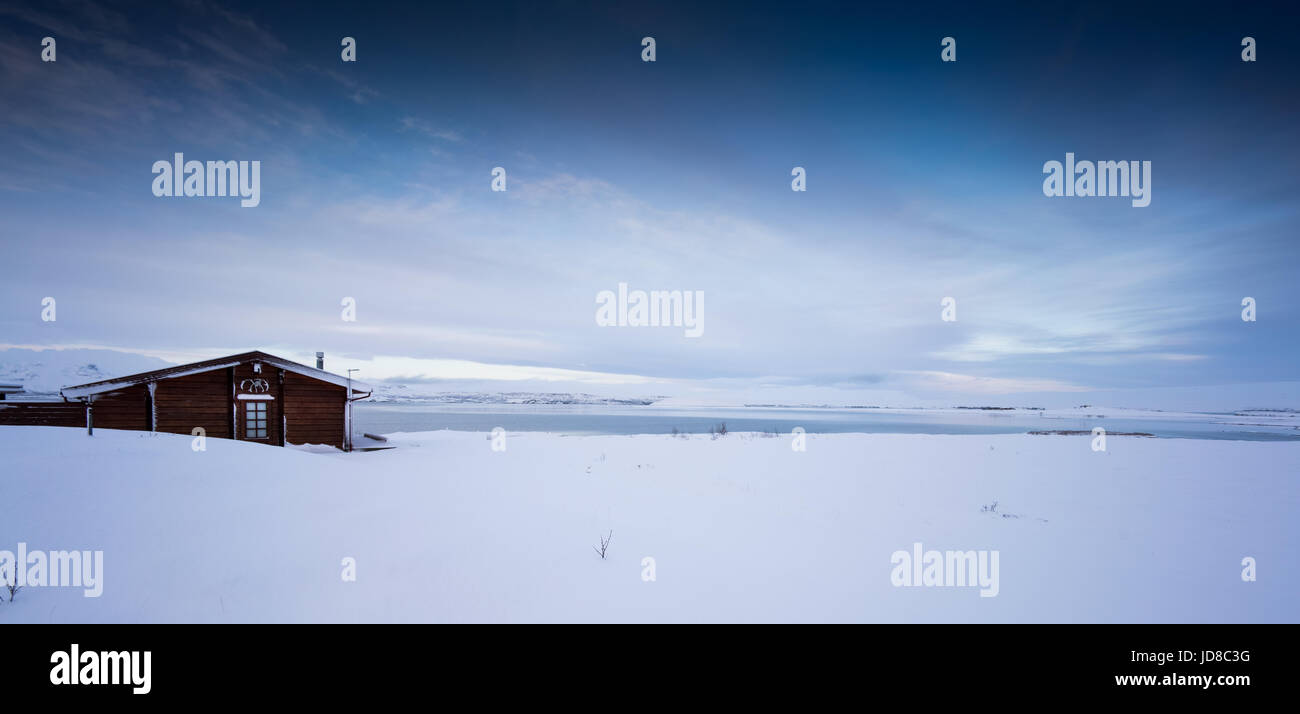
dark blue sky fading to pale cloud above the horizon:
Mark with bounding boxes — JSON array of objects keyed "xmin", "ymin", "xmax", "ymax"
[{"xmin": 0, "ymin": 3, "xmax": 1300, "ymax": 395}]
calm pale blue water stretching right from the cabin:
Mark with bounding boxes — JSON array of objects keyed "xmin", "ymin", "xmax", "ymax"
[{"xmin": 354, "ymin": 402, "xmax": 1300, "ymax": 441}]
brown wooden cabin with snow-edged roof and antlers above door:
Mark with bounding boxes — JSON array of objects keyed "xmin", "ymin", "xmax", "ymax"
[{"xmin": 0, "ymin": 351, "xmax": 373, "ymax": 450}]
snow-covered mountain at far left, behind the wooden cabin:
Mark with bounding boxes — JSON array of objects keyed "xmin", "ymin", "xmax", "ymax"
[{"xmin": 0, "ymin": 349, "xmax": 172, "ymax": 398}]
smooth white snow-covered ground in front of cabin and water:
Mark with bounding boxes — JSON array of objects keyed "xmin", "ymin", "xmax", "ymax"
[{"xmin": 0, "ymin": 427, "xmax": 1300, "ymax": 622}]
